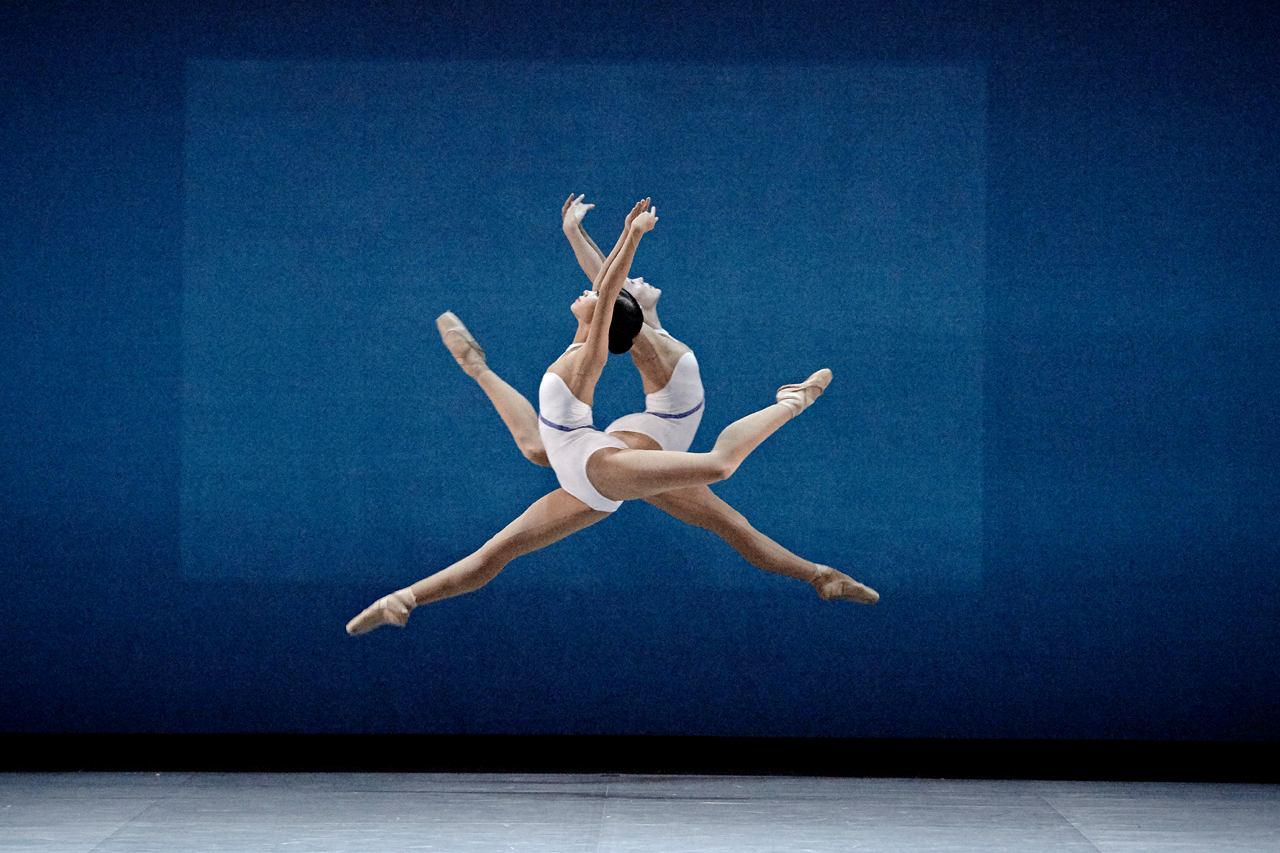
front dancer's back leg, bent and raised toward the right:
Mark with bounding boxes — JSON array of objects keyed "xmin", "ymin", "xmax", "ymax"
[{"xmin": 586, "ymin": 368, "xmax": 831, "ymax": 501}]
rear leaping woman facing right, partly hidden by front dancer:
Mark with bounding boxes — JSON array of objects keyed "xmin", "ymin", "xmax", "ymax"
[{"xmin": 436, "ymin": 195, "xmax": 879, "ymax": 605}]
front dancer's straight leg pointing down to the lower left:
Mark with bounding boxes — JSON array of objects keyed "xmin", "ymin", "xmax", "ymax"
[{"xmin": 347, "ymin": 489, "xmax": 609, "ymax": 634}]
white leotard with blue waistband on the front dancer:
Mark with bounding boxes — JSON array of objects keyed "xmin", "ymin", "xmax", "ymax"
[{"xmin": 538, "ymin": 373, "xmax": 626, "ymax": 512}]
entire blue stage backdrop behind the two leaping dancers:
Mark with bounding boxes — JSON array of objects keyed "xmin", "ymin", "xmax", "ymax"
[{"xmin": 0, "ymin": 3, "xmax": 1280, "ymax": 739}]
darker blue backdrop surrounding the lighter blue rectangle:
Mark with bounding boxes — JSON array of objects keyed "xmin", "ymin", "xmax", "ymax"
[{"xmin": 0, "ymin": 3, "xmax": 1280, "ymax": 740}]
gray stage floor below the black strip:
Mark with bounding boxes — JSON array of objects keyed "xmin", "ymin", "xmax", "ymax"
[{"xmin": 0, "ymin": 774, "xmax": 1280, "ymax": 853}]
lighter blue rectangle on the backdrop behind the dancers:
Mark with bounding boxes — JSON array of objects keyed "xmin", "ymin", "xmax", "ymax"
[{"xmin": 182, "ymin": 61, "xmax": 986, "ymax": 592}]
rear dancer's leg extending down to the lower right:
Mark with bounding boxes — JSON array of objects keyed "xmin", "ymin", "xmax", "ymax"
[{"xmin": 645, "ymin": 485, "xmax": 879, "ymax": 605}]
